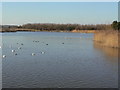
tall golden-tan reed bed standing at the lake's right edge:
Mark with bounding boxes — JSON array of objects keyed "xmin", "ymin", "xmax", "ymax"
[{"xmin": 94, "ymin": 30, "xmax": 120, "ymax": 48}]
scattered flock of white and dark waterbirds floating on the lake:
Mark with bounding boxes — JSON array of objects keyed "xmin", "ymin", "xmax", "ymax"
[{"xmin": 0, "ymin": 40, "xmax": 64, "ymax": 58}]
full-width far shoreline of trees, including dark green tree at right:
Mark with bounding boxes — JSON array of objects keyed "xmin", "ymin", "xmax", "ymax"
[{"xmin": 2, "ymin": 21, "xmax": 120, "ymax": 31}]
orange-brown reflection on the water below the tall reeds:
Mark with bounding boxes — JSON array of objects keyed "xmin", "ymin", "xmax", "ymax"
[{"xmin": 94, "ymin": 42, "xmax": 120, "ymax": 57}]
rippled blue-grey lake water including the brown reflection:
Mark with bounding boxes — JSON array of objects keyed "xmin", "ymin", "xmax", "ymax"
[{"xmin": 2, "ymin": 32, "xmax": 118, "ymax": 88}]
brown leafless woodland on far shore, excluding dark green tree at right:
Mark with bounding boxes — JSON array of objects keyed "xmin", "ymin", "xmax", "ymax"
[{"xmin": 18, "ymin": 23, "xmax": 112, "ymax": 31}]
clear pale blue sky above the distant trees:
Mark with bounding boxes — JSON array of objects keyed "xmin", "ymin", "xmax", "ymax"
[{"xmin": 2, "ymin": 2, "xmax": 118, "ymax": 24}]
